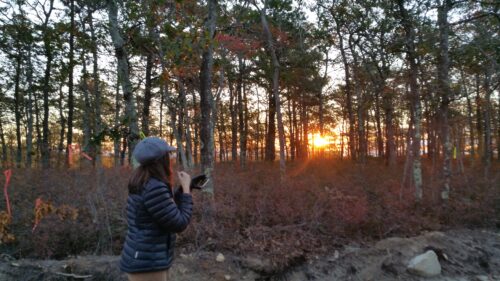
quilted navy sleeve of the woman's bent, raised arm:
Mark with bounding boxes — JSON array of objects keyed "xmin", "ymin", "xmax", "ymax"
[{"xmin": 144, "ymin": 182, "xmax": 193, "ymax": 232}]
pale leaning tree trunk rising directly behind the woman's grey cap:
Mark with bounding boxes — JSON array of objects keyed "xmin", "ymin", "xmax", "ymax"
[{"xmin": 107, "ymin": 0, "xmax": 139, "ymax": 162}]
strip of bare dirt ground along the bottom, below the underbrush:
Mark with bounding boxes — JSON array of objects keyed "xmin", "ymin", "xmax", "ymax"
[{"xmin": 0, "ymin": 230, "xmax": 500, "ymax": 281}]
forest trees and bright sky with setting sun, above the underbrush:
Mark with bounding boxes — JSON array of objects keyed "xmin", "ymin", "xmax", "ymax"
[{"xmin": 0, "ymin": 0, "xmax": 500, "ymax": 199}]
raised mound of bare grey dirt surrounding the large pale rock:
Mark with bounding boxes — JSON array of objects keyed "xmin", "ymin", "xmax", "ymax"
[{"xmin": 283, "ymin": 230, "xmax": 500, "ymax": 281}]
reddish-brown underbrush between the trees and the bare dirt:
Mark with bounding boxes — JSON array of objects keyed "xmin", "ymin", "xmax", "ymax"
[{"xmin": 0, "ymin": 159, "xmax": 500, "ymax": 268}]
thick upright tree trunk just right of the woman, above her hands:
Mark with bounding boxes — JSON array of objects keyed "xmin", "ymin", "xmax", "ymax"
[{"xmin": 200, "ymin": 0, "xmax": 217, "ymax": 194}]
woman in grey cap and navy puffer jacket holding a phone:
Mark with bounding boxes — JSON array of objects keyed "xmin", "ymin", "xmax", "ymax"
[{"xmin": 120, "ymin": 137, "xmax": 193, "ymax": 281}]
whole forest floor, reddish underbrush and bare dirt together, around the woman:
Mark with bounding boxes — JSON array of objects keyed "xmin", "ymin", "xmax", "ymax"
[{"xmin": 0, "ymin": 159, "xmax": 500, "ymax": 281}]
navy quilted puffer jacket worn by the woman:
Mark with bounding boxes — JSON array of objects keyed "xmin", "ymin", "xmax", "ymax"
[{"xmin": 120, "ymin": 178, "xmax": 193, "ymax": 273}]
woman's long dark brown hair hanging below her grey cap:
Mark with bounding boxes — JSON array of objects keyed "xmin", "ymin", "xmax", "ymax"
[{"xmin": 128, "ymin": 153, "xmax": 173, "ymax": 194}]
